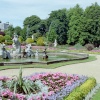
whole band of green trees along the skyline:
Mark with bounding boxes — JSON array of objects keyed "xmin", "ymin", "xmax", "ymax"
[{"xmin": 5, "ymin": 3, "xmax": 100, "ymax": 46}]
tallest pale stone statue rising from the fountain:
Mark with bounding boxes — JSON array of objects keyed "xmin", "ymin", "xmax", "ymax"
[{"xmin": 12, "ymin": 33, "xmax": 21, "ymax": 54}]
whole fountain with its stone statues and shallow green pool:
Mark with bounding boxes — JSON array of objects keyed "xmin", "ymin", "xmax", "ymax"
[{"xmin": 0, "ymin": 34, "xmax": 88, "ymax": 66}]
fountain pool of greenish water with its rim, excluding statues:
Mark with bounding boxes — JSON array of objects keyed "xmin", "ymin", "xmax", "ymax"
[{"xmin": 0, "ymin": 52, "xmax": 89, "ymax": 66}]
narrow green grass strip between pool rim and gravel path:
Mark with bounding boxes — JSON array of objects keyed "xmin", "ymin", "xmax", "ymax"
[{"xmin": 0, "ymin": 56, "xmax": 96, "ymax": 70}]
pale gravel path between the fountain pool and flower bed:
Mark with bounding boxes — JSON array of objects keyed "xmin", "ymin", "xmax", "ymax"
[{"xmin": 0, "ymin": 55, "xmax": 100, "ymax": 83}]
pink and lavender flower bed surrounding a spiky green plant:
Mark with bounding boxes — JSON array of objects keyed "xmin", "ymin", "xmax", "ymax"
[{"xmin": 0, "ymin": 71, "xmax": 88, "ymax": 100}]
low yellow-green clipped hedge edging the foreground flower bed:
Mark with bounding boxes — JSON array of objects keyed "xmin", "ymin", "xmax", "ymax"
[{"xmin": 64, "ymin": 78, "xmax": 96, "ymax": 100}]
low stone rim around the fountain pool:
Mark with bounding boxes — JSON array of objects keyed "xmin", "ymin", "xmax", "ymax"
[{"xmin": 0, "ymin": 52, "xmax": 89, "ymax": 66}]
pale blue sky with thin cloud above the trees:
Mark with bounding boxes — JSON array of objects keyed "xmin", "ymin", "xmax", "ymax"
[{"xmin": 0, "ymin": 0, "xmax": 100, "ymax": 27}]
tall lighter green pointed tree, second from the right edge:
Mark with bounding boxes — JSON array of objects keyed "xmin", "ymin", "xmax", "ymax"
[{"xmin": 67, "ymin": 4, "xmax": 83, "ymax": 45}]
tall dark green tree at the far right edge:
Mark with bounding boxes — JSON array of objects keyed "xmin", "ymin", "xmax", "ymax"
[{"xmin": 84, "ymin": 3, "xmax": 100, "ymax": 46}]
